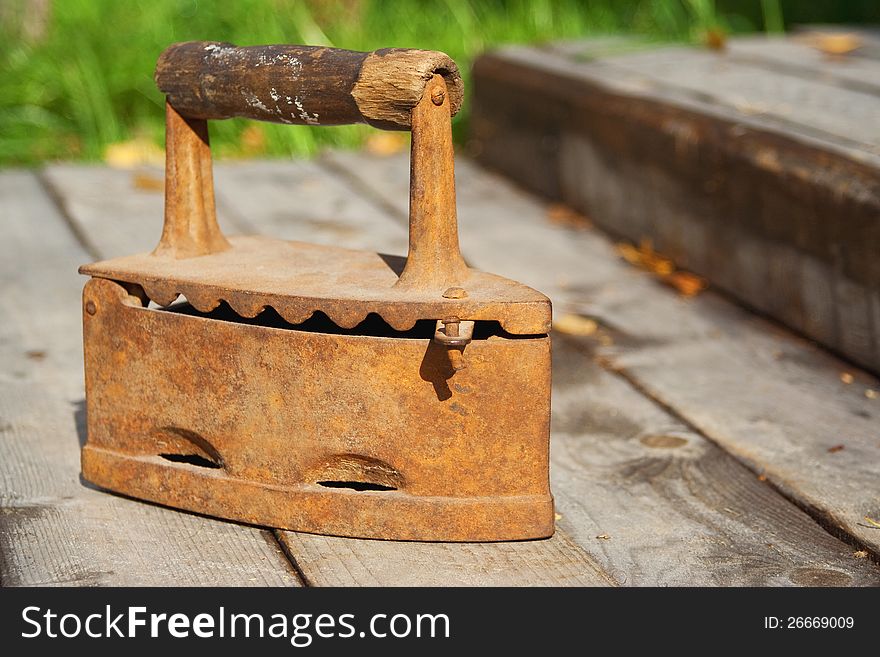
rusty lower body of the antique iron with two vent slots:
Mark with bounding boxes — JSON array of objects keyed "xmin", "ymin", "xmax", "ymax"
[{"xmin": 83, "ymin": 279, "xmax": 553, "ymax": 541}]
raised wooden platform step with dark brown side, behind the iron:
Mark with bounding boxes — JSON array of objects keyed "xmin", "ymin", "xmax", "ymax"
[{"xmin": 472, "ymin": 28, "xmax": 880, "ymax": 373}]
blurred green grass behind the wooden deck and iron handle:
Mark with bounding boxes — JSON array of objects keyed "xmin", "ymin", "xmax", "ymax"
[{"xmin": 0, "ymin": 0, "xmax": 880, "ymax": 166}]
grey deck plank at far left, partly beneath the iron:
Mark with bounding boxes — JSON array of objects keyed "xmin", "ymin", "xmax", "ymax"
[{"xmin": 0, "ymin": 171, "xmax": 299, "ymax": 586}]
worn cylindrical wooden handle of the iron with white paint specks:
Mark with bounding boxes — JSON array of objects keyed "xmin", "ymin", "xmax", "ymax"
[{"xmin": 155, "ymin": 41, "xmax": 464, "ymax": 130}]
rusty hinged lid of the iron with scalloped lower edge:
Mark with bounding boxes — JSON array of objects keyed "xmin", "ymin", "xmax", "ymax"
[{"xmin": 80, "ymin": 237, "xmax": 550, "ymax": 334}]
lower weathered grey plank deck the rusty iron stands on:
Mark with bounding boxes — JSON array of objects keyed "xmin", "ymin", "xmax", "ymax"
[{"xmin": 0, "ymin": 147, "xmax": 880, "ymax": 586}]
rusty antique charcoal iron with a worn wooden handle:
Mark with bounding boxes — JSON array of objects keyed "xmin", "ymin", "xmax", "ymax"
[{"xmin": 80, "ymin": 42, "xmax": 554, "ymax": 541}]
